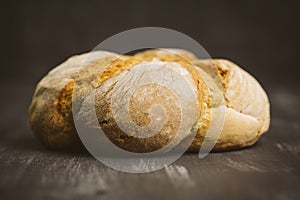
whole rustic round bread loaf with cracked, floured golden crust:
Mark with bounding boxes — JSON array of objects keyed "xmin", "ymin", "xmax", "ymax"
[{"xmin": 29, "ymin": 49, "xmax": 270, "ymax": 152}]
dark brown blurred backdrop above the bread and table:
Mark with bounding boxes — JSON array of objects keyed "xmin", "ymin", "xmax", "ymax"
[{"xmin": 1, "ymin": 0, "xmax": 300, "ymax": 89}]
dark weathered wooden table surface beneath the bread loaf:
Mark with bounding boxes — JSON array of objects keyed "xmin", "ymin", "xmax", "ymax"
[{"xmin": 0, "ymin": 83, "xmax": 300, "ymax": 200}]
